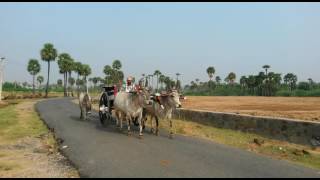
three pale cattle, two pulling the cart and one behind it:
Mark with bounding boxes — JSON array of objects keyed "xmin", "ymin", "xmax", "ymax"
[{"xmin": 79, "ymin": 88, "xmax": 181, "ymax": 138}]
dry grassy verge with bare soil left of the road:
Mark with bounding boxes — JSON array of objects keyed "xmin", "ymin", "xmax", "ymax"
[{"xmin": 0, "ymin": 100, "xmax": 79, "ymax": 178}]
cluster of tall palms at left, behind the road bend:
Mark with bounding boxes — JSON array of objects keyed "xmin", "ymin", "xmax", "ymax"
[{"xmin": 27, "ymin": 43, "xmax": 91, "ymax": 97}]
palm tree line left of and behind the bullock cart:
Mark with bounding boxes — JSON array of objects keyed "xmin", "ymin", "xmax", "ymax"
[{"xmin": 24, "ymin": 43, "xmax": 181, "ymax": 97}]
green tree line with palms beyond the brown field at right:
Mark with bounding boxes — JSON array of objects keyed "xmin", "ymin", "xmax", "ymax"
[{"xmin": 184, "ymin": 65, "xmax": 320, "ymax": 96}]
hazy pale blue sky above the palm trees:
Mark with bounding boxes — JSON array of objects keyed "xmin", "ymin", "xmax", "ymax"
[{"xmin": 0, "ymin": 2, "xmax": 320, "ymax": 84}]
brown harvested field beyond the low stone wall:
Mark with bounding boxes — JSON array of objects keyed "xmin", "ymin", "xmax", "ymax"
[{"xmin": 182, "ymin": 96, "xmax": 320, "ymax": 122}]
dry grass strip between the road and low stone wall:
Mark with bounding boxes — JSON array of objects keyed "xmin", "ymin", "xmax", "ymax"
[{"xmin": 146, "ymin": 119, "xmax": 320, "ymax": 169}]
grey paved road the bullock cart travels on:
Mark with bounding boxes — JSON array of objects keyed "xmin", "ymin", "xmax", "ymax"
[{"xmin": 36, "ymin": 98, "xmax": 320, "ymax": 178}]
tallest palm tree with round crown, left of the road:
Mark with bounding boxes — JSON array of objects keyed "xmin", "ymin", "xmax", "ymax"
[{"xmin": 40, "ymin": 43, "xmax": 58, "ymax": 97}]
